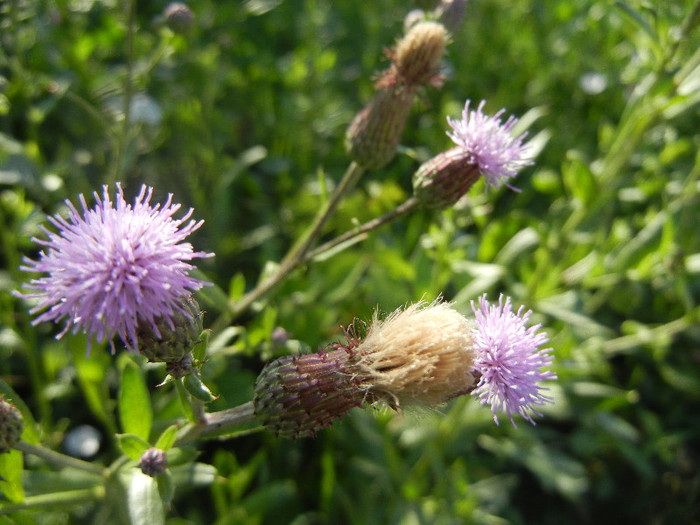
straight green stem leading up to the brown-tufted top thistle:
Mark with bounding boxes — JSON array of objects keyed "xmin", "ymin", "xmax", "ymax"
[{"xmin": 226, "ymin": 162, "xmax": 364, "ymax": 322}]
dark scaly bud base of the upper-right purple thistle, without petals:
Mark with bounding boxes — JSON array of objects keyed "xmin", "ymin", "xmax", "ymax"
[{"xmin": 413, "ymin": 147, "xmax": 481, "ymax": 209}]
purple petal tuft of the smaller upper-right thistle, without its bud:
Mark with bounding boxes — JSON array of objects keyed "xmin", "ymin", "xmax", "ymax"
[{"xmin": 447, "ymin": 100, "xmax": 533, "ymax": 191}]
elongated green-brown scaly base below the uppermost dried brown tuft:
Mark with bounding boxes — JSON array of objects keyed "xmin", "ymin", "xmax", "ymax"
[{"xmin": 345, "ymin": 84, "xmax": 414, "ymax": 170}]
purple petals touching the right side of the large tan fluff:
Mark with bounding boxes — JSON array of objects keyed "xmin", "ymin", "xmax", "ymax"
[{"xmin": 472, "ymin": 294, "xmax": 557, "ymax": 427}]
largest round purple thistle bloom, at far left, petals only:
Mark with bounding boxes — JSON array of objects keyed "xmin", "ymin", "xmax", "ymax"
[{"xmin": 17, "ymin": 183, "xmax": 213, "ymax": 353}]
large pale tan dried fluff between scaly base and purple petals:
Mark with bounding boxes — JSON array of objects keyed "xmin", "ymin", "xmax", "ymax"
[{"xmin": 348, "ymin": 302, "xmax": 476, "ymax": 408}]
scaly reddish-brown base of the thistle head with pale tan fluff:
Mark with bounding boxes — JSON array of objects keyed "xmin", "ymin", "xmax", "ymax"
[{"xmin": 253, "ymin": 349, "xmax": 363, "ymax": 438}]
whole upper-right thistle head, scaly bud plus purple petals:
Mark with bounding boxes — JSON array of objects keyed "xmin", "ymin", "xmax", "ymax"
[{"xmin": 413, "ymin": 100, "xmax": 532, "ymax": 209}]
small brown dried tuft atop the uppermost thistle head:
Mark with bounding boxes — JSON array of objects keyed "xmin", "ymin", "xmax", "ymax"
[{"xmin": 394, "ymin": 22, "xmax": 447, "ymax": 85}]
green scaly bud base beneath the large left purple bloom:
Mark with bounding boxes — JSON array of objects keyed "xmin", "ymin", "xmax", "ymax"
[{"xmin": 137, "ymin": 296, "xmax": 204, "ymax": 363}]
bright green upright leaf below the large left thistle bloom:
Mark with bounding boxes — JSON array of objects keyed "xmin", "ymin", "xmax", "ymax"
[{"xmin": 119, "ymin": 354, "xmax": 153, "ymax": 441}]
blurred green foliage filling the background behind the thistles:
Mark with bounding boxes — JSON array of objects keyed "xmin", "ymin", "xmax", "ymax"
[{"xmin": 0, "ymin": 0, "xmax": 700, "ymax": 525}]
